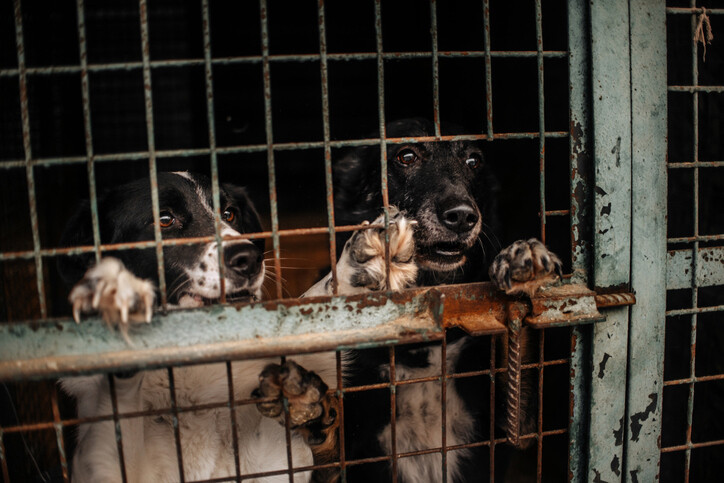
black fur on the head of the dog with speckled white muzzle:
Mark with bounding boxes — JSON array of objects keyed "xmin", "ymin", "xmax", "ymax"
[{"xmin": 58, "ymin": 172, "xmax": 264, "ymax": 303}]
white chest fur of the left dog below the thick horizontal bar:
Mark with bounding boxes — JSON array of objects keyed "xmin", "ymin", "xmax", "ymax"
[{"xmin": 61, "ymin": 353, "xmax": 336, "ymax": 483}]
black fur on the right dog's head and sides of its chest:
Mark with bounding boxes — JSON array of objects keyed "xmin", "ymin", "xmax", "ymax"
[{"xmin": 334, "ymin": 119, "xmax": 504, "ymax": 482}]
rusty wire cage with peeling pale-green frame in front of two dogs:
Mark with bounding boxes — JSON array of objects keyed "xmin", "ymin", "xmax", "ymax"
[{"xmin": 0, "ymin": 0, "xmax": 724, "ymax": 482}]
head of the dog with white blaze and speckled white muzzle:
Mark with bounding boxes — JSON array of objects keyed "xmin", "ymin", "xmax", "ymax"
[{"xmin": 59, "ymin": 172, "xmax": 264, "ymax": 307}]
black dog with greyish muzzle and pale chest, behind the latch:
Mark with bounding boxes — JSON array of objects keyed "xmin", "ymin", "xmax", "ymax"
[{"xmin": 334, "ymin": 119, "xmax": 561, "ymax": 481}]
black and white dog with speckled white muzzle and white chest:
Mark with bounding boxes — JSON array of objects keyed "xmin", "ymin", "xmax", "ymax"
[{"xmin": 60, "ymin": 172, "xmax": 417, "ymax": 483}]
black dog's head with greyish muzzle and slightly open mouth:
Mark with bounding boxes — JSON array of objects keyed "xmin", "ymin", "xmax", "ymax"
[{"xmin": 334, "ymin": 119, "xmax": 497, "ymax": 273}]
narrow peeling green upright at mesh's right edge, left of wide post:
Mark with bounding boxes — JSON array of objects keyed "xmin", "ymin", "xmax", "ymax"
[{"xmin": 568, "ymin": 0, "xmax": 593, "ymax": 482}]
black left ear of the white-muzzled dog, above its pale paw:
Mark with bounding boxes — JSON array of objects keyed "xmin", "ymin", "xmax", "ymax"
[{"xmin": 56, "ymin": 200, "xmax": 95, "ymax": 287}]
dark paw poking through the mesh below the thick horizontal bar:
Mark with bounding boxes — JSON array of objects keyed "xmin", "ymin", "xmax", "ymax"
[{"xmin": 252, "ymin": 360, "xmax": 337, "ymax": 436}]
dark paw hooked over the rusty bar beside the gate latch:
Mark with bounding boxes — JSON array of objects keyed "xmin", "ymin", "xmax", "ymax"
[{"xmin": 489, "ymin": 238, "xmax": 563, "ymax": 297}]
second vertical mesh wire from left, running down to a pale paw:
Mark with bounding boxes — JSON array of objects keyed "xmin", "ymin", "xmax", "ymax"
[{"xmin": 76, "ymin": 0, "xmax": 101, "ymax": 263}]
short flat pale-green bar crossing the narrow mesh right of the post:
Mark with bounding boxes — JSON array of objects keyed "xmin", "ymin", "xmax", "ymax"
[{"xmin": 666, "ymin": 247, "xmax": 724, "ymax": 290}]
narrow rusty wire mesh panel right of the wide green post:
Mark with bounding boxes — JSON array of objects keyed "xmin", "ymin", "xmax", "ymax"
[{"xmin": 661, "ymin": 2, "xmax": 724, "ymax": 481}]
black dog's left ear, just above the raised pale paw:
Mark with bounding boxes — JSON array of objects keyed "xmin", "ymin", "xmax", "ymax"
[{"xmin": 332, "ymin": 146, "xmax": 382, "ymax": 225}]
